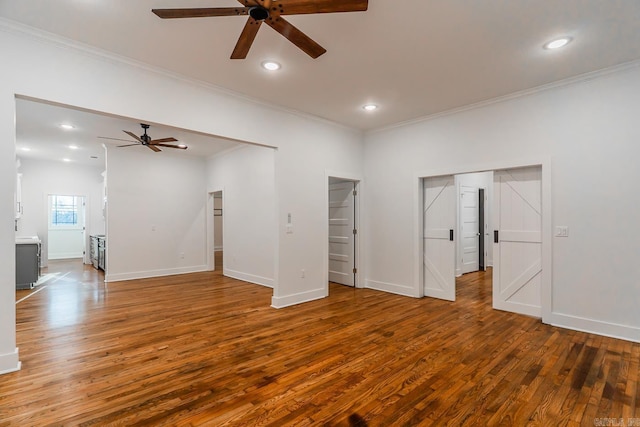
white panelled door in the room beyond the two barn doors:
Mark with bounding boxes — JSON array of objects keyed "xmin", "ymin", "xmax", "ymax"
[{"xmin": 460, "ymin": 185, "xmax": 480, "ymax": 274}]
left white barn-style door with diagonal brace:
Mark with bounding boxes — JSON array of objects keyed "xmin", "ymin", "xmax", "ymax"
[{"xmin": 423, "ymin": 176, "xmax": 456, "ymax": 301}]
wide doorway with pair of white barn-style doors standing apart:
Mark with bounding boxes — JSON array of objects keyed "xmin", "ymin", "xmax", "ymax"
[{"xmin": 421, "ymin": 165, "xmax": 545, "ymax": 317}]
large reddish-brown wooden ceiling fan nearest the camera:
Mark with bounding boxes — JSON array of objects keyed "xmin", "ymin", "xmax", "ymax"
[{"xmin": 151, "ymin": 0, "xmax": 368, "ymax": 59}]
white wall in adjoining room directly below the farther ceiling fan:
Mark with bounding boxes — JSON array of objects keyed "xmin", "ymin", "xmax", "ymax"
[{"xmin": 105, "ymin": 147, "xmax": 207, "ymax": 282}]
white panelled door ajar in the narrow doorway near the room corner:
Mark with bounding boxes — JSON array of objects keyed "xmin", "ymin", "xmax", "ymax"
[{"xmin": 329, "ymin": 182, "xmax": 356, "ymax": 286}]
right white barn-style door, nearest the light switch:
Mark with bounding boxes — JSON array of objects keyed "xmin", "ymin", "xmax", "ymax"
[{"xmin": 493, "ymin": 167, "xmax": 542, "ymax": 317}]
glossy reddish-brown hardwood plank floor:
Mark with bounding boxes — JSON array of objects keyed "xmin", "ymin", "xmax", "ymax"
[{"xmin": 0, "ymin": 263, "xmax": 640, "ymax": 426}]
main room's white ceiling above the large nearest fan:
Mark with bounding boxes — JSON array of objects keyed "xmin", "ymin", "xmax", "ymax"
[{"xmin": 0, "ymin": 0, "xmax": 640, "ymax": 162}]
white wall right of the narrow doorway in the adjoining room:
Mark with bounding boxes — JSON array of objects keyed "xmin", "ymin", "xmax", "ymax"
[{"xmin": 207, "ymin": 145, "xmax": 277, "ymax": 287}]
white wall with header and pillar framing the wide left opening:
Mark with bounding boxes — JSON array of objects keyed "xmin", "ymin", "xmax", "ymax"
[{"xmin": 0, "ymin": 20, "xmax": 363, "ymax": 372}]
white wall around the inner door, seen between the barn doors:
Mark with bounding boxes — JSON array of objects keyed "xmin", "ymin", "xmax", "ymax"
[{"xmin": 455, "ymin": 171, "xmax": 493, "ymax": 276}]
